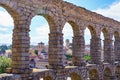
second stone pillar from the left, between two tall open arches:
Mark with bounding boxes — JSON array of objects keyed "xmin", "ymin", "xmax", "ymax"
[{"xmin": 48, "ymin": 32, "xmax": 64, "ymax": 69}]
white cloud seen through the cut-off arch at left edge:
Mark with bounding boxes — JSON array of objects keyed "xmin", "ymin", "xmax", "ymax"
[{"xmin": 0, "ymin": 10, "xmax": 13, "ymax": 44}]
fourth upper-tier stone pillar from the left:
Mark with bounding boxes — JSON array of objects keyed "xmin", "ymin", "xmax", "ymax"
[{"xmin": 90, "ymin": 36, "xmax": 101, "ymax": 64}]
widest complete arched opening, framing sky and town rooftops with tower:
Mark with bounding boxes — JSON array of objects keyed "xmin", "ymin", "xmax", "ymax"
[{"xmin": 29, "ymin": 15, "xmax": 50, "ymax": 69}]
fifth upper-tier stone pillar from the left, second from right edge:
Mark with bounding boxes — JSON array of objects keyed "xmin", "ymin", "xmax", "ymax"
[{"xmin": 104, "ymin": 39, "xmax": 114, "ymax": 63}]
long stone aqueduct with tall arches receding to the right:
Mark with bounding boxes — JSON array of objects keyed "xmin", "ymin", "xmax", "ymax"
[{"xmin": 0, "ymin": 0, "xmax": 120, "ymax": 80}]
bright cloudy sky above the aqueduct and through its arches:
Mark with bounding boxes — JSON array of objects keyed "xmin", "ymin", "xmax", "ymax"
[{"xmin": 0, "ymin": 0, "xmax": 120, "ymax": 45}]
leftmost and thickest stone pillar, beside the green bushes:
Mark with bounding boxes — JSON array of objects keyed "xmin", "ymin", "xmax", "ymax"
[{"xmin": 12, "ymin": 22, "xmax": 31, "ymax": 80}]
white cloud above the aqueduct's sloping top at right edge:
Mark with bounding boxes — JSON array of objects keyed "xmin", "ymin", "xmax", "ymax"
[{"xmin": 94, "ymin": 1, "xmax": 120, "ymax": 21}]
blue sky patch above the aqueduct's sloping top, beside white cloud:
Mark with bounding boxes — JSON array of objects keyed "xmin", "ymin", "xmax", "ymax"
[{"xmin": 63, "ymin": 0, "xmax": 118, "ymax": 10}]
